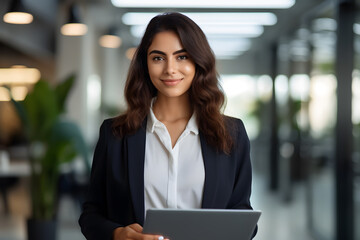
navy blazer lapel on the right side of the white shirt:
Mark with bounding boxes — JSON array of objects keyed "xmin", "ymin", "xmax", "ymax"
[{"xmin": 200, "ymin": 132, "xmax": 219, "ymax": 208}]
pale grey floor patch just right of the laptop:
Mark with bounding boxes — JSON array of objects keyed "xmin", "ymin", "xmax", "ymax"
[{"xmin": 252, "ymin": 175, "xmax": 313, "ymax": 240}]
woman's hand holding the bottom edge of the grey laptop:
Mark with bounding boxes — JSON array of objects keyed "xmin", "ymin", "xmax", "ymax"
[{"xmin": 113, "ymin": 223, "xmax": 169, "ymax": 240}]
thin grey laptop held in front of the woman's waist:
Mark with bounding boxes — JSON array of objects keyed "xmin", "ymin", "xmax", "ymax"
[{"xmin": 143, "ymin": 209, "xmax": 261, "ymax": 240}]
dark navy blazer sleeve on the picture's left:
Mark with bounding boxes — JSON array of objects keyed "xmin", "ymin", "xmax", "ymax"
[{"xmin": 79, "ymin": 120, "xmax": 121, "ymax": 240}]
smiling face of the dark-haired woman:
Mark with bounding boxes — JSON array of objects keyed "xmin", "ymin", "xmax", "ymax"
[{"xmin": 147, "ymin": 31, "xmax": 195, "ymax": 97}]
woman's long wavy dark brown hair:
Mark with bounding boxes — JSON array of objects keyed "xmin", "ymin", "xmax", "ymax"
[{"xmin": 113, "ymin": 13, "xmax": 233, "ymax": 153}]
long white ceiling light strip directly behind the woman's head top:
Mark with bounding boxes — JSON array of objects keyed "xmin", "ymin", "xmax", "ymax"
[{"xmin": 122, "ymin": 12, "xmax": 277, "ymax": 25}]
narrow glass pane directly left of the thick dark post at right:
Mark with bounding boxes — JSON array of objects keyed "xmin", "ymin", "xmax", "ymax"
[{"xmin": 308, "ymin": 10, "xmax": 337, "ymax": 240}]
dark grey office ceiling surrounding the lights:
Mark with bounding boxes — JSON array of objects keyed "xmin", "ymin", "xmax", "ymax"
[{"xmin": 0, "ymin": 0, "xmax": 332, "ymax": 74}]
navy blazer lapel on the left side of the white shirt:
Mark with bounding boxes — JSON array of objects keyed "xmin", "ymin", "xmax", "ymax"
[{"xmin": 127, "ymin": 119, "xmax": 146, "ymax": 225}]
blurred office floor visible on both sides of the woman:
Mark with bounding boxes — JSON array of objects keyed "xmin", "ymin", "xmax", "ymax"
[{"xmin": 0, "ymin": 171, "xmax": 312, "ymax": 240}]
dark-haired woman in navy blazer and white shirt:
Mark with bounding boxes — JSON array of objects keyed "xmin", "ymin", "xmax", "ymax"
[{"xmin": 79, "ymin": 13, "xmax": 251, "ymax": 240}]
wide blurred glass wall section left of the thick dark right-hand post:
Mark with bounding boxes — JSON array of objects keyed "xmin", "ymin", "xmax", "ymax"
[{"xmin": 275, "ymin": 4, "xmax": 340, "ymax": 240}]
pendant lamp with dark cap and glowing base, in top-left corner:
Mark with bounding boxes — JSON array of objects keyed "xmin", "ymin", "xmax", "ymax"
[{"xmin": 3, "ymin": 0, "xmax": 34, "ymax": 24}]
